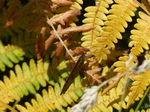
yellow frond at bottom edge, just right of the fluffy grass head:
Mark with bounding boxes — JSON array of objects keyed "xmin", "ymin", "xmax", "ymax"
[{"xmin": 89, "ymin": 78, "xmax": 126, "ymax": 112}]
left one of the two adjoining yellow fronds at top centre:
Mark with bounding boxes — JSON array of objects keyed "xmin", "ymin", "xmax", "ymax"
[{"xmin": 81, "ymin": 0, "xmax": 109, "ymax": 59}]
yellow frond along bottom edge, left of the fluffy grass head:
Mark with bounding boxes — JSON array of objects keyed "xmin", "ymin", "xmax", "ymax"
[{"xmin": 16, "ymin": 77, "xmax": 83, "ymax": 112}]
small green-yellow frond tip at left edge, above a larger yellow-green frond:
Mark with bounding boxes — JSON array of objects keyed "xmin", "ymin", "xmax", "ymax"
[{"xmin": 0, "ymin": 40, "xmax": 25, "ymax": 71}]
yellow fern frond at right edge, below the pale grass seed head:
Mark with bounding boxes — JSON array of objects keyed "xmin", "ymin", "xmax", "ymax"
[{"xmin": 126, "ymin": 70, "xmax": 150, "ymax": 106}]
